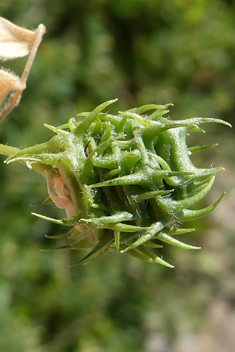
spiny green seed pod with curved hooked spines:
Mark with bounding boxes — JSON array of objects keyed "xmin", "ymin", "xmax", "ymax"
[{"xmin": 6, "ymin": 100, "xmax": 229, "ymax": 267}]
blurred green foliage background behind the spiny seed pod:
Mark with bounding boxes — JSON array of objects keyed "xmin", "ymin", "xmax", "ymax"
[{"xmin": 0, "ymin": 0, "xmax": 235, "ymax": 352}]
